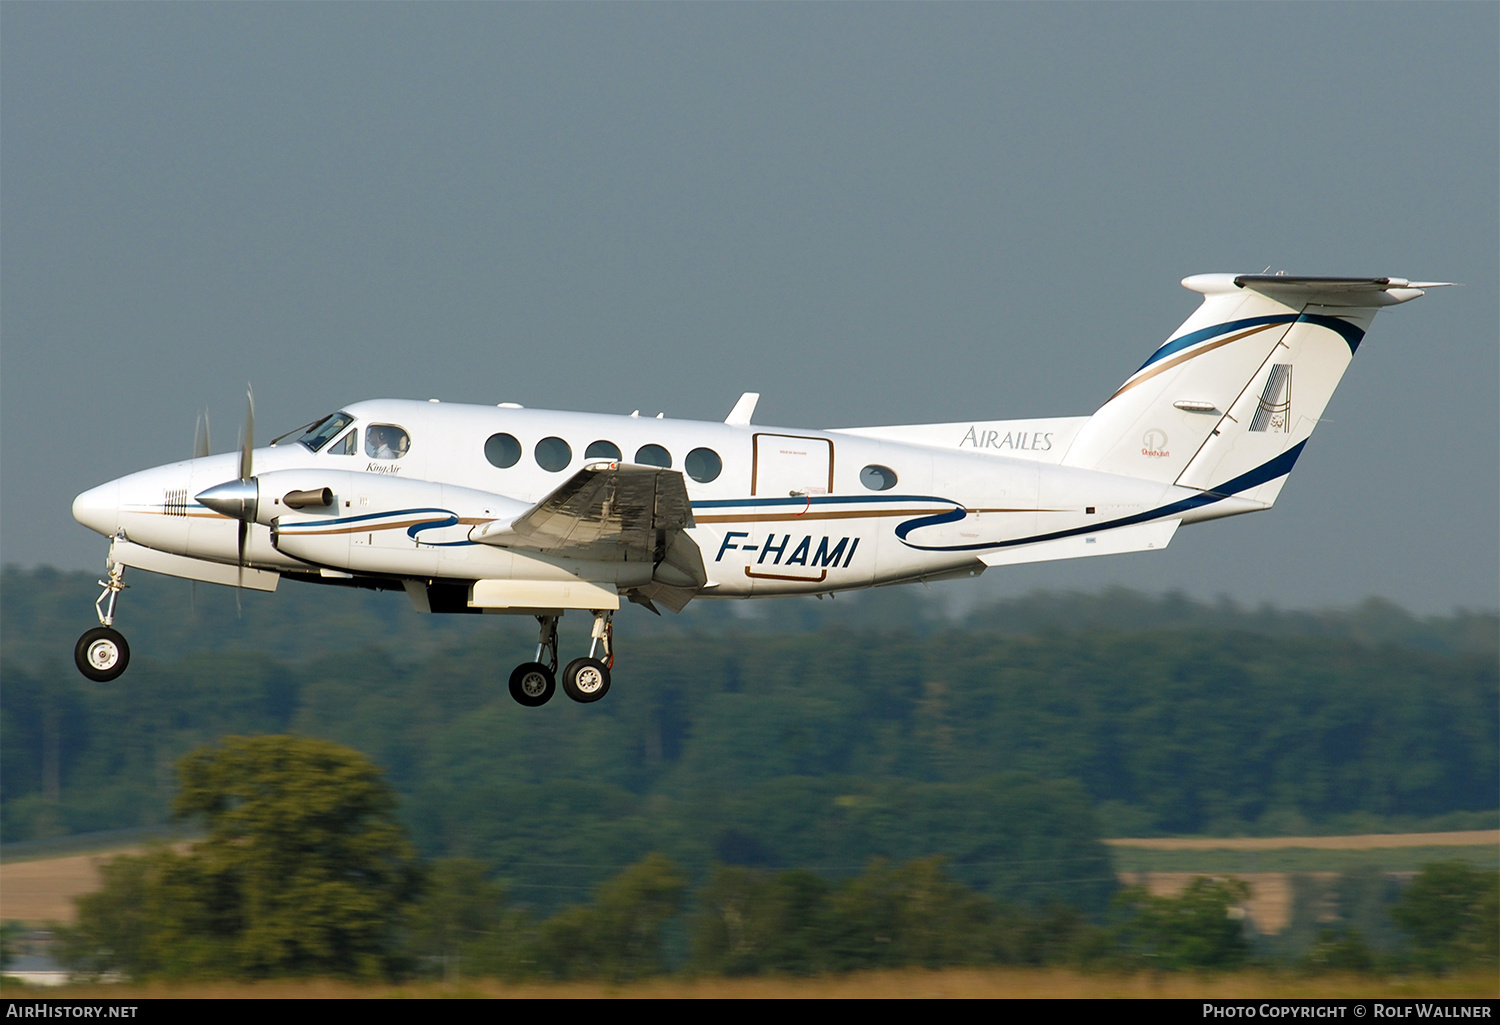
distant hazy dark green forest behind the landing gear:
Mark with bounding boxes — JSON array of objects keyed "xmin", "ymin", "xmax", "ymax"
[{"xmin": 0, "ymin": 570, "xmax": 1500, "ymax": 911}]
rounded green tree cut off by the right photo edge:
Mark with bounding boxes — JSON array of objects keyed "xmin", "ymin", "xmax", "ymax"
[{"xmin": 1391, "ymin": 861, "xmax": 1500, "ymax": 971}]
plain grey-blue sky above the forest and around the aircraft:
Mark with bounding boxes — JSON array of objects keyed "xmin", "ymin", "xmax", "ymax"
[{"xmin": 0, "ymin": 3, "xmax": 1500, "ymax": 611}]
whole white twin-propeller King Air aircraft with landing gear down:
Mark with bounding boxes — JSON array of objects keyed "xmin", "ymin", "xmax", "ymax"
[{"xmin": 74, "ymin": 275, "xmax": 1446, "ymax": 705}]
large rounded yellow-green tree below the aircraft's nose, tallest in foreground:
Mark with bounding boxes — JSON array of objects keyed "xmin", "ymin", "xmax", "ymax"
[{"xmin": 68, "ymin": 737, "xmax": 414, "ymax": 977}]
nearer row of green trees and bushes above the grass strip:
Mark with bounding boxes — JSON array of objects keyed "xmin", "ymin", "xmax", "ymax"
[{"xmin": 52, "ymin": 735, "xmax": 1500, "ymax": 981}]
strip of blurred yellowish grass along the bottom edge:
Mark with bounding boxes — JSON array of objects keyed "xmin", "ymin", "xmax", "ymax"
[{"xmin": 6, "ymin": 968, "xmax": 1500, "ymax": 999}]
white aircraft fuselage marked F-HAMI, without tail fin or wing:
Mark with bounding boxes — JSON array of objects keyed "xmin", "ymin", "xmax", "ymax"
[{"xmin": 74, "ymin": 399, "xmax": 1245, "ymax": 597}]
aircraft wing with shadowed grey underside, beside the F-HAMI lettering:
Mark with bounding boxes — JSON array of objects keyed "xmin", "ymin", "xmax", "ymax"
[{"xmin": 470, "ymin": 462, "xmax": 695, "ymax": 561}]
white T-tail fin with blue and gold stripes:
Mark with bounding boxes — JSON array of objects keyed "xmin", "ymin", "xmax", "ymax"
[{"xmin": 1064, "ymin": 275, "xmax": 1439, "ymax": 506}]
